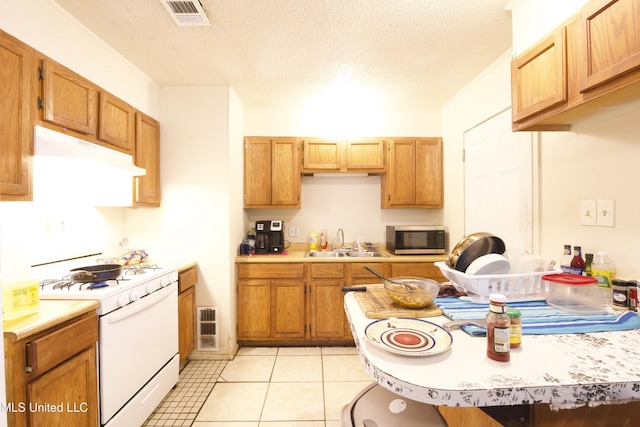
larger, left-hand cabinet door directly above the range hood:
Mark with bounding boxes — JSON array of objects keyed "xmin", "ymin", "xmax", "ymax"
[{"xmin": 42, "ymin": 59, "xmax": 99, "ymax": 136}]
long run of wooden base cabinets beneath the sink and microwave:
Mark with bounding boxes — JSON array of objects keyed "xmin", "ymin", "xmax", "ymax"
[{"xmin": 237, "ymin": 262, "xmax": 445, "ymax": 345}]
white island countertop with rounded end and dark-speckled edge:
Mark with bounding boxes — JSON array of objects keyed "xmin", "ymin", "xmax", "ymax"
[{"xmin": 345, "ymin": 292, "xmax": 640, "ymax": 410}]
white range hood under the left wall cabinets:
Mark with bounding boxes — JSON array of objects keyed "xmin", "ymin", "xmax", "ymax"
[{"xmin": 34, "ymin": 125, "xmax": 147, "ymax": 177}]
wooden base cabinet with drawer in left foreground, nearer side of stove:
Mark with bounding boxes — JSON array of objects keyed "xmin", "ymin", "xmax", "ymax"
[{"xmin": 4, "ymin": 311, "xmax": 98, "ymax": 427}]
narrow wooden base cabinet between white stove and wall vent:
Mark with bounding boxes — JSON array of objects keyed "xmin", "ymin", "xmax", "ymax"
[{"xmin": 178, "ymin": 266, "xmax": 198, "ymax": 366}]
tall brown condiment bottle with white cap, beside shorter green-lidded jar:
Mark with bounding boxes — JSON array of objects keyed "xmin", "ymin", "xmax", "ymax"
[{"xmin": 487, "ymin": 294, "xmax": 511, "ymax": 362}]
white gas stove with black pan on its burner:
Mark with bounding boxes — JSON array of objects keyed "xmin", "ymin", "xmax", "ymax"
[{"xmin": 33, "ymin": 254, "xmax": 180, "ymax": 427}]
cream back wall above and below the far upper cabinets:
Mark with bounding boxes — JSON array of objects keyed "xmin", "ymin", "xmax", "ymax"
[{"xmin": 238, "ymin": 108, "xmax": 448, "ymax": 247}]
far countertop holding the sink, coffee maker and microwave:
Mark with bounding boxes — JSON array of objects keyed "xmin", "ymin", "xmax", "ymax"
[{"xmin": 235, "ymin": 243, "xmax": 448, "ymax": 264}]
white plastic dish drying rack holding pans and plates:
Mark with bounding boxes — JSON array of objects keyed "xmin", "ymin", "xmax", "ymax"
[{"xmin": 434, "ymin": 262, "xmax": 554, "ymax": 304}]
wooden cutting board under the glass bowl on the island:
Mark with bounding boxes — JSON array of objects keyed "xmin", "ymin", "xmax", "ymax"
[{"xmin": 355, "ymin": 287, "xmax": 442, "ymax": 319}]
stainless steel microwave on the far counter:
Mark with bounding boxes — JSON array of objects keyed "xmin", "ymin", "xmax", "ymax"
[{"xmin": 387, "ymin": 225, "xmax": 445, "ymax": 255}]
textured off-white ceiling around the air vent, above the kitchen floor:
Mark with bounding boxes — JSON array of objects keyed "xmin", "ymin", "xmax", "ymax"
[{"xmin": 50, "ymin": 0, "xmax": 511, "ymax": 108}]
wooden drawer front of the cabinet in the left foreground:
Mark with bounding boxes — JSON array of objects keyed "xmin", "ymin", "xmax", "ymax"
[{"xmin": 26, "ymin": 314, "xmax": 98, "ymax": 377}]
